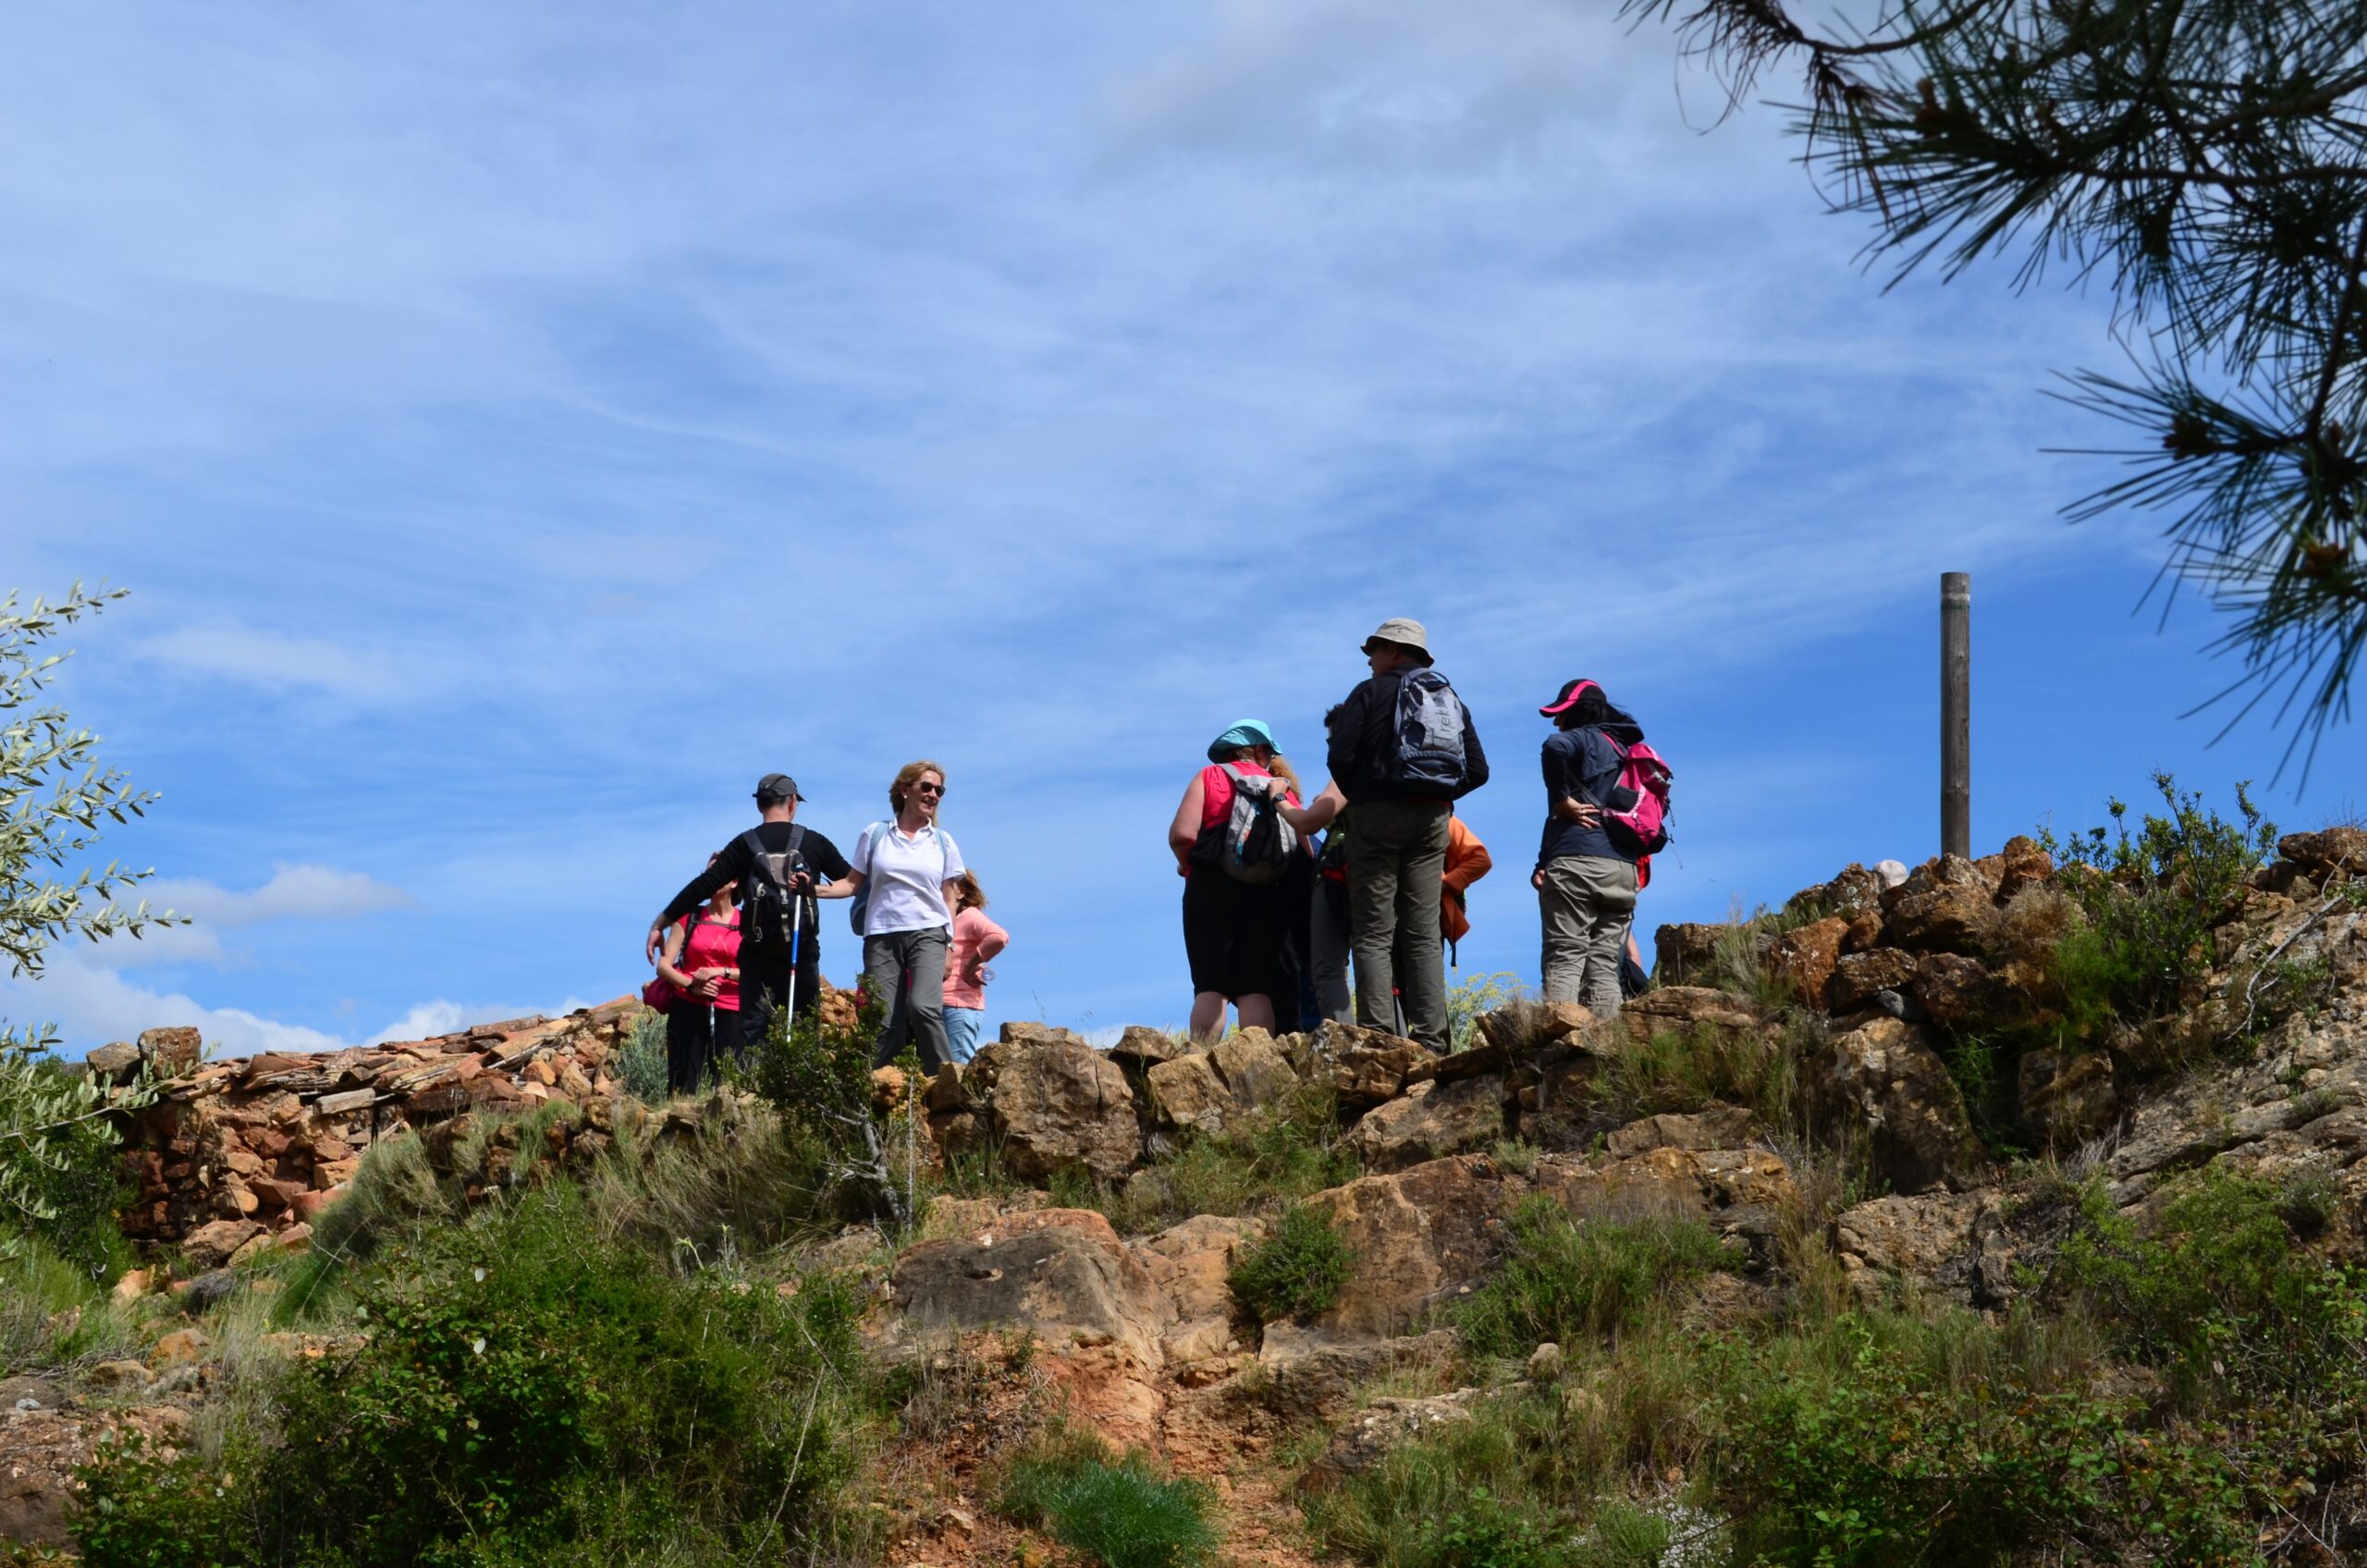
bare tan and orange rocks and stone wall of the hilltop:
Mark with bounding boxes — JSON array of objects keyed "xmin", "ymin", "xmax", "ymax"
[{"xmin": 14, "ymin": 829, "xmax": 2367, "ymax": 1563}]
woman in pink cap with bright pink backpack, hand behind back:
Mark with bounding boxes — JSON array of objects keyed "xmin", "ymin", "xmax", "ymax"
[{"xmin": 1529, "ymin": 680, "xmax": 1669, "ymax": 1019}]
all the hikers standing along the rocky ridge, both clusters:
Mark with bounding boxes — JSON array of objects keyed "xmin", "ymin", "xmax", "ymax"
[{"xmin": 644, "ymin": 620, "xmax": 1669, "ymax": 1092}]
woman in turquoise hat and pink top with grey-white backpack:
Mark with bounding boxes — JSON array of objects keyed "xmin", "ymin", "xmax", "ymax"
[{"xmin": 1167, "ymin": 717, "xmax": 1302, "ymax": 1040}]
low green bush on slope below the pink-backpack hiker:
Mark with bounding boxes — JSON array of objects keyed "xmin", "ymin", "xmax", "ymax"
[{"xmin": 1461, "ymin": 1196, "xmax": 1733, "ymax": 1354}]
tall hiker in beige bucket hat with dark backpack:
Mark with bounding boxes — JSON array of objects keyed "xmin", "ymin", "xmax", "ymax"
[{"xmin": 1328, "ymin": 619, "xmax": 1487, "ymax": 1051}]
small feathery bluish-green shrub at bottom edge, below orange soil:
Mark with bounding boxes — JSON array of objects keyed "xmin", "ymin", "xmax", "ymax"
[{"xmin": 1001, "ymin": 1426, "xmax": 1217, "ymax": 1568}]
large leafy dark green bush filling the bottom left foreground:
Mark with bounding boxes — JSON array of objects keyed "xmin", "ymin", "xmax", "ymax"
[{"xmin": 80, "ymin": 1184, "xmax": 880, "ymax": 1568}]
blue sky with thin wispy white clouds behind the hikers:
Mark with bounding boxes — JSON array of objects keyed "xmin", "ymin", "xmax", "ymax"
[{"xmin": 0, "ymin": 0, "xmax": 2360, "ymax": 1049}]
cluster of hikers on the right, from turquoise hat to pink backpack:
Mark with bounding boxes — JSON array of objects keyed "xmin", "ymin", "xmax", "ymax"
[{"xmin": 1167, "ymin": 619, "xmax": 1669, "ymax": 1051}]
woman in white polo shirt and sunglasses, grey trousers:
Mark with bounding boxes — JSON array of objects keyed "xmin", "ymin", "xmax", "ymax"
[{"xmin": 816, "ymin": 763, "xmax": 968, "ymax": 1073}]
